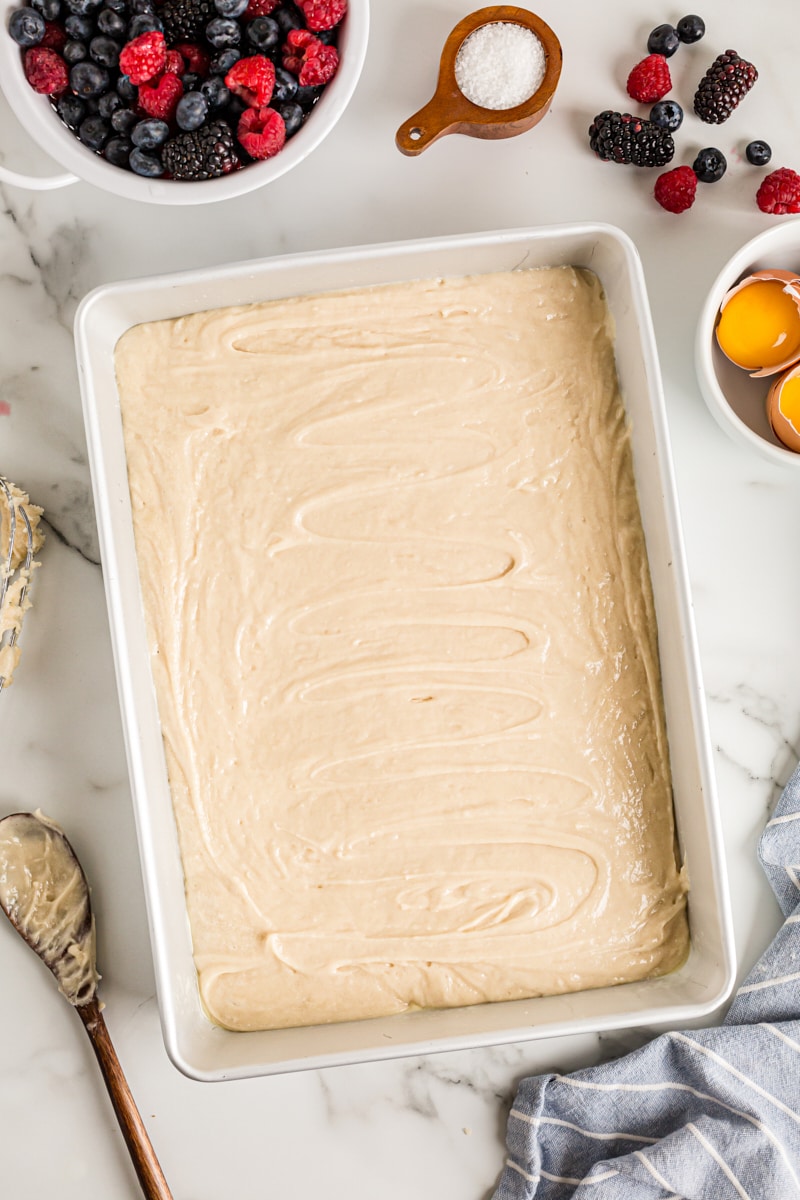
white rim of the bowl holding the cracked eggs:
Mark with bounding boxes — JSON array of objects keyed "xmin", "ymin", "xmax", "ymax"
[{"xmin": 694, "ymin": 217, "xmax": 800, "ymax": 468}]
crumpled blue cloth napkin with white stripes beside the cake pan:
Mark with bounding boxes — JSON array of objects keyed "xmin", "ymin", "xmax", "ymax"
[{"xmin": 494, "ymin": 767, "xmax": 800, "ymax": 1200}]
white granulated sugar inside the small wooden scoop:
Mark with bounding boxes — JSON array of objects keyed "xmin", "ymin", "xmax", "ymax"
[{"xmin": 456, "ymin": 22, "xmax": 546, "ymax": 109}]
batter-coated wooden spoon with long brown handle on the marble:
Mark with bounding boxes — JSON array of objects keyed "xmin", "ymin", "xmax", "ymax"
[{"xmin": 0, "ymin": 812, "xmax": 173, "ymax": 1200}]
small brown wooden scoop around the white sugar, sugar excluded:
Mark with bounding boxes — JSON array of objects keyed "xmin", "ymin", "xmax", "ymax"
[{"xmin": 395, "ymin": 5, "xmax": 561, "ymax": 155}]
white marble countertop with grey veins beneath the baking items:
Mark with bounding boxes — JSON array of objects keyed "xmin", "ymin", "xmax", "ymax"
[{"xmin": 0, "ymin": 0, "xmax": 800, "ymax": 1200}]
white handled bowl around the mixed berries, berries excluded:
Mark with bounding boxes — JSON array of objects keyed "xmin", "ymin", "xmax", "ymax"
[{"xmin": 0, "ymin": 0, "xmax": 369, "ymax": 204}]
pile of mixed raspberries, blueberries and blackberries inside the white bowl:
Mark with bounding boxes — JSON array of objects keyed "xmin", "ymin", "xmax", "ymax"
[{"xmin": 8, "ymin": 0, "xmax": 347, "ymax": 180}]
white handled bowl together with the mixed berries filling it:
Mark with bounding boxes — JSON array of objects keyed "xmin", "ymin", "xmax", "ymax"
[{"xmin": 0, "ymin": 0, "xmax": 369, "ymax": 204}]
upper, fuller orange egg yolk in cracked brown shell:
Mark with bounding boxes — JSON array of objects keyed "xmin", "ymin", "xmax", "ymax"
[{"xmin": 717, "ymin": 280, "xmax": 800, "ymax": 371}]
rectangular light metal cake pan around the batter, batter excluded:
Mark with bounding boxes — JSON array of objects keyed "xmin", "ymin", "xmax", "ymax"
[{"xmin": 76, "ymin": 224, "xmax": 735, "ymax": 1080}]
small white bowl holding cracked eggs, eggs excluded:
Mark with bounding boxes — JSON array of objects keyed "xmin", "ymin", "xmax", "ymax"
[{"xmin": 694, "ymin": 218, "xmax": 800, "ymax": 470}]
